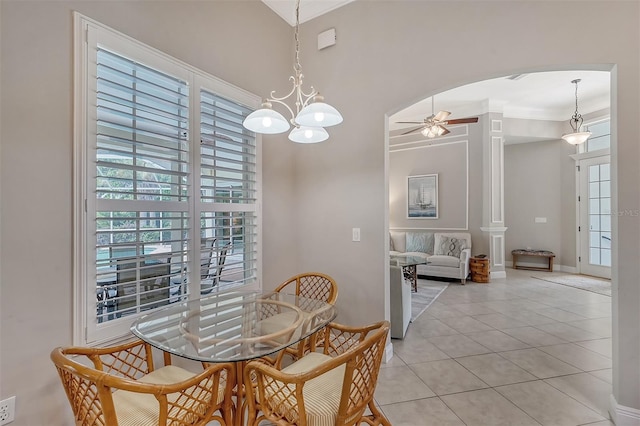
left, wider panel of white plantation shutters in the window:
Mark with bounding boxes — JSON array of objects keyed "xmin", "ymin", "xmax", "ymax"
[{"xmin": 95, "ymin": 47, "xmax": 189, "ymax": 323}]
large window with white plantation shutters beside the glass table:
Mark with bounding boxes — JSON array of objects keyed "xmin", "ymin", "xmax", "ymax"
[{"xmin": 76, "ymin": 15, "xmax": 260, "ymax": 343}]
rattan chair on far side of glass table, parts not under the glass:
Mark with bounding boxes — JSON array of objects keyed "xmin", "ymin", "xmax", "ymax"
[{"xmin": 274, "ymin": 272, "xmax": 338, "ymax": 360}]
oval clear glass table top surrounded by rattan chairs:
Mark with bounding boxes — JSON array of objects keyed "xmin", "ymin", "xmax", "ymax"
[{"xmin": 131, "ymin": 290, "xmax": 337, "ymax": 362}]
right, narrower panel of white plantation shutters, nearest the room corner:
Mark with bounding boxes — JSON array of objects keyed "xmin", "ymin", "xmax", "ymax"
[{"xmin": 200, "ymin": 90, "xmax": 258, "ymax": 284}]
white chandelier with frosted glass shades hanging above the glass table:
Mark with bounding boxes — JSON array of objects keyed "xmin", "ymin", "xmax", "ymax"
[{"xmin": 242, "ymin": 0, "xmax": 342, "ymax": 143}]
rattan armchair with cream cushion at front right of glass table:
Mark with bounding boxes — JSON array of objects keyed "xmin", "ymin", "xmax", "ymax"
[{"xmin": 244, "ymin": 321, "xmax": 391, "ymax": 426}]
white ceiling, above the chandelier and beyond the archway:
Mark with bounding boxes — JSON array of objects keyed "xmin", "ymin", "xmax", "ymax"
[{"xmin": 262, "ymin": 0, "xmax": 610, "ymax": 130}]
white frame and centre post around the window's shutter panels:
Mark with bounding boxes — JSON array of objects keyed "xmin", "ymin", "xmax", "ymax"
[{"xmin": 73, "ymin": 12, "xmax": 262, "ymax": 345}]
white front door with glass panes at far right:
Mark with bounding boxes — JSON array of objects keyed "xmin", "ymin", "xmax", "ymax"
[{"xmin": 578, "ymin": 155, "xmax": 612, "ymax": 278}]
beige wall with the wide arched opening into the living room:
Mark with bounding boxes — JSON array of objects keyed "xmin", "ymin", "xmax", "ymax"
[{"xmin": 296, "ymin": 1, "xmax": 640, "ymax": 416}]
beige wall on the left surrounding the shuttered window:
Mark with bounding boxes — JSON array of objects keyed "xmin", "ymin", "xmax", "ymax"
[{"xmin": 0, "ymin": 0, "xmax": 297, "ymax": 426}]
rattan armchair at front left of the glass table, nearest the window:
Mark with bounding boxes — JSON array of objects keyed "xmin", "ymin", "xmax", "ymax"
[{"xmin": 51, "ymin": 340, "xmax": 235, "ymax": 426}]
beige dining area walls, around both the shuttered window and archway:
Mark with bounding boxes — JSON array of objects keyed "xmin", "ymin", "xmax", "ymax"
[{"xmin": 0, "ymin": 0, "xmax": 640, "ymax": 426}]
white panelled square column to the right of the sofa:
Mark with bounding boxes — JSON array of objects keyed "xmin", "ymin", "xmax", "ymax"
[{"xmin": 480, "ymin": 112, "xmax": 507, "ymax": 278}]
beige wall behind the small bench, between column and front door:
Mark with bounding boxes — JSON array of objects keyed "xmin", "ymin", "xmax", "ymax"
[{"xmin": 504, "ymin": 139, "xmax": 576, "ymax": 266}]
